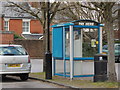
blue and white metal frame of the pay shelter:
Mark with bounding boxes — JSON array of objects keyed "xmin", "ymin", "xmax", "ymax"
[{"xmin": 52, "ymin": 20, "xmax": 103, "ymax": 80}]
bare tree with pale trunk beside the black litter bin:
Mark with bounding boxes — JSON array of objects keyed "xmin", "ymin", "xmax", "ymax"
[{"xmin": 57, "ymin": 2, "xmax": 118, "ymax": 81}]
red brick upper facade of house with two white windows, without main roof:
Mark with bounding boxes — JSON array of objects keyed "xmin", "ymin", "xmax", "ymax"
[{"xmin": 0, "ymin": 15, "xmax": 43, "ymax": 39}]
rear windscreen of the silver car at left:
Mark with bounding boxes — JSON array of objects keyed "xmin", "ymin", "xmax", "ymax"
[{"xmin": 0, "ymin": 46, "xmax": 27, "ymax": 55}]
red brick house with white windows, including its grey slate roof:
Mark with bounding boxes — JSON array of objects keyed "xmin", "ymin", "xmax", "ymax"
[{"xmin": 0, "ymin": 2, "xmax": 43, "ymax": 39}]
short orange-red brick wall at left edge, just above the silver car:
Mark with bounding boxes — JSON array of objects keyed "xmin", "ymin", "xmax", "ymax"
[{"xmin": 0, "ymin": 31, "xmax": 14, "ymax": 44}]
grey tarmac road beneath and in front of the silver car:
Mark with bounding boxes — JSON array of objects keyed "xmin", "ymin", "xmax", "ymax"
[{"xmin": 0, "ymin": 76, "xmax": 65, "ymax": 88}]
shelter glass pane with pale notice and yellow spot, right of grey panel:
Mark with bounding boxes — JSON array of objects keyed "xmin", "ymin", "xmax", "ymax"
[{"xmin": 82, "ymin": 28, "xmax": 99, "ymax": 57}]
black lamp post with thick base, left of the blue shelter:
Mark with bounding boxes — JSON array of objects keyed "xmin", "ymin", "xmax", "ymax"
[{"xmin": 45, "ymin": 0, "xmax": 52, "ymax": 79}]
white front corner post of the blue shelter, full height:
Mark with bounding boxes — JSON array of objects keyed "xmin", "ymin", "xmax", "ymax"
[{"xmin": 70, "ymin": 26, "xmax": 74, "ymax": 80}]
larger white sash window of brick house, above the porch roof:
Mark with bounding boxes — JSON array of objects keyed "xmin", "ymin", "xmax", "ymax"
[{"xmin": 22, "ymin": 20, "xmax": 30, "ymax": 34}]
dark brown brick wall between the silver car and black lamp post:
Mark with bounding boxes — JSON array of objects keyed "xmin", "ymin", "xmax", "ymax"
[{"xmin": 14, "ymin": 40, "xmax": 44, "ymax": 58}]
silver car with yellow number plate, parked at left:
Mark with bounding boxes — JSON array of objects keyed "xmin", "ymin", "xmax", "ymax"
[{"xmin": 0, "ymin": 44, "xmax": 31, "ymax": 81}]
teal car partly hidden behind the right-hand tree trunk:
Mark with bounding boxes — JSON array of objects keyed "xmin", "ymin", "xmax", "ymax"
[{"xmin": 102, "ymin": 43, "xmax": 120, "ymax": 62}]
